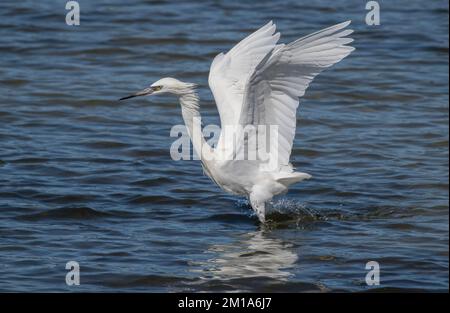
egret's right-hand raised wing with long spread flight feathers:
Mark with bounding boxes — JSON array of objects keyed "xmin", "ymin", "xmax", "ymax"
[{"xmin": 238, "ymin": 21, "xmax": 354, "ymax": 167}]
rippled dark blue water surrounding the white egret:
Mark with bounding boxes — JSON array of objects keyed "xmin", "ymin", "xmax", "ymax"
[{"xmin": 0, "ymin": 0, "xmax": 449, "ymax": 292}]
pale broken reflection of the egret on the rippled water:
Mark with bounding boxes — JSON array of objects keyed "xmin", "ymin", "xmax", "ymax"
[{"xmin": 195, "ymin": 231, "xmax": 298, "ymax": 281}]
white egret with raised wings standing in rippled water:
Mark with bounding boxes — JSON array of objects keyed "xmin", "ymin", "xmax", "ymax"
[{"xmin": 120, "ymin": 21, "xmax": 354, "ymax": 223}]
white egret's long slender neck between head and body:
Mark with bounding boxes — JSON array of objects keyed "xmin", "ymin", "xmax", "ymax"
[{"xmin": 180, "ymin": 88, "xmax": 212, "ymax": 163}]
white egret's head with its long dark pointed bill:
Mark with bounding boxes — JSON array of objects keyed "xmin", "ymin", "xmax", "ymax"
[{"xmin": 119, "ymin": 77, "xmax": 195, "ymax": 100}]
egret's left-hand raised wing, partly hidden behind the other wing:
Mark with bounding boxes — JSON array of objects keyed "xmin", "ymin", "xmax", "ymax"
[{"xmin": 208, "ymin": 21, "xmax": 280, "ymax": 128}]
